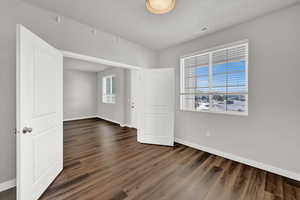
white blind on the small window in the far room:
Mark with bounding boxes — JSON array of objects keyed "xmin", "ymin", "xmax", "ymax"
[{"xmin": 102, "ymin": 76, "xmax": 116, "ymax": 104}]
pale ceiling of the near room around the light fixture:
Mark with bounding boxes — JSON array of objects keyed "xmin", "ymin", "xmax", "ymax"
[{"xmin": 23, "ymin": 0, "xmax": 300, "ymax": 49}]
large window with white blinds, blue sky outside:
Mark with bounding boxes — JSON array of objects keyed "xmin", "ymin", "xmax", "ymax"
[{"xmin": 180, "ymin": 42, "xmax": 248, "ymax": 115}]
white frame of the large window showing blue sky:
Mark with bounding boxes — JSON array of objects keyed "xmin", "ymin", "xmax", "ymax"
[{"xmin": 179, "ymin": 40, "xmax": 249, "ymax": 116}]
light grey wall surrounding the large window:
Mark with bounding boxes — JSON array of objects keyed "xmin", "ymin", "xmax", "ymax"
[{"xmin": 159, "ymin": 4, "xmax": 300, "ymax": 179}]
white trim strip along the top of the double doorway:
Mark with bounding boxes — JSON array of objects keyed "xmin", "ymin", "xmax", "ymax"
[{"xmin": 60, "ymin": 50, "xmax": 141, "ymax": 70}]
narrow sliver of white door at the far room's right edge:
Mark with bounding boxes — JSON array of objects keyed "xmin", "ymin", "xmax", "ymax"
[{"xmin": 130, "ymin": 70, "xmax": 139, "ymax": 128}]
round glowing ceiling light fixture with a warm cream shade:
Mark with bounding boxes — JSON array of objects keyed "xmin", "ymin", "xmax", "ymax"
[{"xmin": 146, "ymin": 0, "xmax": 176, "ymax": 14}]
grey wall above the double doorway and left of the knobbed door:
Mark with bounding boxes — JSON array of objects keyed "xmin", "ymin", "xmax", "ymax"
[{"xmin": 0, "ymin": 0, "xmax": 157, "ymax": 183}]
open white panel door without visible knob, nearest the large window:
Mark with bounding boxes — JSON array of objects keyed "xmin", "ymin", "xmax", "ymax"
[{"xmin": 138, "ymin": 68, "xmax": 175, "ymax": 146}]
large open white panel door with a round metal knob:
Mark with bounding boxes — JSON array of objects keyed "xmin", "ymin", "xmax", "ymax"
[{"xmin": 17, "ymin": 25, "xmax": 63, "ymax": 200}]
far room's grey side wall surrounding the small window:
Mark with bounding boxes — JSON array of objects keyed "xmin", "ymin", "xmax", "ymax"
[{"xmin": 98, "ymin": 68, "xmax": 130, "ymax": 125}]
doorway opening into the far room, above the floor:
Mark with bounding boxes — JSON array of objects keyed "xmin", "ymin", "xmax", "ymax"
[{"xmin": 62, "ymin": 51, "xmax": 140, "ymax": 128}]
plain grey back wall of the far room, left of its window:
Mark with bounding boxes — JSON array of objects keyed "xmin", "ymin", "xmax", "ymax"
[{"xmin": 64, "ymin": 70, "xmax": 97, "ymax": 120}]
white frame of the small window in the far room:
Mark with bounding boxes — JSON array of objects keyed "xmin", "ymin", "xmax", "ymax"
[{"xmin": 102, "ymin": 75, "xmax": 117, "ymax": 104}]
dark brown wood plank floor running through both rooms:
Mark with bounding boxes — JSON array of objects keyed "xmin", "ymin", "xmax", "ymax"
[{"xmin": 0, "ymin": 119, "xmax": 300, "ymax": 200}]
